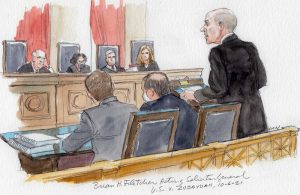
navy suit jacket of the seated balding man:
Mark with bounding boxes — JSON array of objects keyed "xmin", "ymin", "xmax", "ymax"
[{"xmin": 140, "ymin": 94, "xmax": 197, "ymax": 150}]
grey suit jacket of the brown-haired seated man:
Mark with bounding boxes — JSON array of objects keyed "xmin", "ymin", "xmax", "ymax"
[{"xmin": 62, "ymin": 96, "xmax": 137, "ymax": 162}]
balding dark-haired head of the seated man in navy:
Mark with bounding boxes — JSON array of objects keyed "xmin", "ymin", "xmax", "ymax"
[{"xmin": 142, "ymin": 72, "xmax": 170, "ymax": 97}]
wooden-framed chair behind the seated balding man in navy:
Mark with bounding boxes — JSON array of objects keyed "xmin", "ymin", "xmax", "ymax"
[{"xmin": 122, "ymin": 109, "xmax": 179, "ymax": 158}]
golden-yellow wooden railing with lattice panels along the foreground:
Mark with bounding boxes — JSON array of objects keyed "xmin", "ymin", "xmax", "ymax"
[{"xmin": 28, "ymin": 127, "xmax": 298, "ymax": 183}]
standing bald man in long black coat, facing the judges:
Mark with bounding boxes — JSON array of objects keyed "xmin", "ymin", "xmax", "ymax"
[{"xmin": 181, "ymin": 8, "xmax": 267, "ymax": 138}]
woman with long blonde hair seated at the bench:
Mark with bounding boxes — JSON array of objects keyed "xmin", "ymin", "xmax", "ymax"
[{"xmin": 136, "ymin": 45, "xmax": 159, "ymax": 71}]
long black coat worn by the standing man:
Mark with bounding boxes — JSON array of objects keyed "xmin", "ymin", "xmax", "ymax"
[{"xmin": 194, "ymin": 34, "xmax": 267, "ymax": 138}]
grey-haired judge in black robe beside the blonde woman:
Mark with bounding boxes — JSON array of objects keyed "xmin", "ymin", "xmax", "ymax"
[{"xmin": 101, "ymin": 49, "xmax": 124, "ymax": 73}]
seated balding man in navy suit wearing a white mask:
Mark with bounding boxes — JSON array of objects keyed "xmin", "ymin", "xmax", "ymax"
[{"xmin": 140, "ymin": 72, "xmax": 197, "ymax": 150}]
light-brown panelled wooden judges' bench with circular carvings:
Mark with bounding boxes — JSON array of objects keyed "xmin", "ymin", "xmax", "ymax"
[{"xmin": 5, "ymin": 68, "xmax": 202, "ymax": 130}]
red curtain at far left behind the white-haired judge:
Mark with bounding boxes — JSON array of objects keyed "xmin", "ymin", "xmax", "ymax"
[{"xmin": 15, "ymin": 4, "xmax": 50, "ymax": 63}]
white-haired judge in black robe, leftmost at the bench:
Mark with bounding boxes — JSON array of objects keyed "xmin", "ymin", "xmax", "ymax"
[{"xmin": 17, "ymin": 50, "xmax": 52, "ymax": 73}]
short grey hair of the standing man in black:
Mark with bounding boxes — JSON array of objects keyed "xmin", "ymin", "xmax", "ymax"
[{"xmin": 206, "ymin": 8, "xmax": 237, "ymax": 32}]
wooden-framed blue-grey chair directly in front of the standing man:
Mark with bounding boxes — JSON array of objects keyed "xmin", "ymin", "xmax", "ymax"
[{"xmin": 194, "ymin": 102, "xmax": 241, "ymax": 146}]
